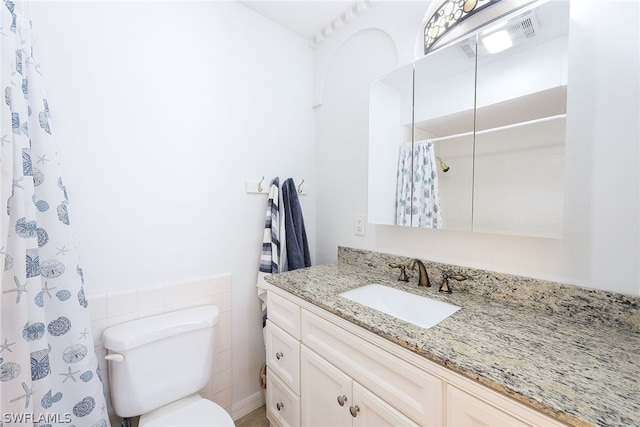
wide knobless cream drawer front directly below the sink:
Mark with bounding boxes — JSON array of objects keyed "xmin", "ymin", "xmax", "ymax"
[{"xmin": 301, "ymin": 310, "xmax": 443, "ymax": 425}]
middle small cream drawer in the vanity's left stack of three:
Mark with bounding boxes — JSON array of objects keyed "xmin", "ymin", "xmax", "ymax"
[{"xmin": 266, "ymin": 320, "xmax": 300, "ymax": 395}]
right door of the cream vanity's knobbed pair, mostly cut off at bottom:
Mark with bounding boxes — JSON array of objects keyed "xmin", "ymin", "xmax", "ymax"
[{"xmin": 349, "ymin": 382, "xmax": 418, "ymax": 427}]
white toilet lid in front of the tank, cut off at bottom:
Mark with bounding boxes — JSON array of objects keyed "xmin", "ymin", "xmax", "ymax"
[{"xmin": 138, "ymin": 395, "xmax": 235, "ymax": 427}]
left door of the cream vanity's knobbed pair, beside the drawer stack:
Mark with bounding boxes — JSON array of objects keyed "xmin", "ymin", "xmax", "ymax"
[{"xmin": 300, "ymin": 346, "xmax": 352, "ymax": 427}]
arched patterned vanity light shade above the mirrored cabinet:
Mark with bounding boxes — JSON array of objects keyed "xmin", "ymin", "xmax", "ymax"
[{"xmin": 424, "ymin": 0, "xmax": 501, "ymax": 55}]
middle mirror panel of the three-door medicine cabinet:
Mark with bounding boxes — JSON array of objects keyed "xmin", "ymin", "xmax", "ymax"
[{"xmin": 412, "ymin": 37, "xmax": 476, "ymax": 231}]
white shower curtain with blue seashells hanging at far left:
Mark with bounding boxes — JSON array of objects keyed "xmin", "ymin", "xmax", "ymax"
[{"xmin": 0, "ymin": 0, "xmax": 109, "ymax": 427}]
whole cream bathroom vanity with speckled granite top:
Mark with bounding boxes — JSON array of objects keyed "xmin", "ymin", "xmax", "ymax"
[{"xmin": 266, "ymin": 248, "xmax": 640, "ymax": 426}]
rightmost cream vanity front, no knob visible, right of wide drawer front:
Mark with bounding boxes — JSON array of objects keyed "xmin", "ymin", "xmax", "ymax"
[{"xmin": 447, "ymin": 385, "xmax": 530, "ymax": 427}]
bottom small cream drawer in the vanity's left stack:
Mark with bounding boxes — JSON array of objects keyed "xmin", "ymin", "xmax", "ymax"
[{"xmin": 267, "ymin": 368, "xmax": 300, "ymax": 427}]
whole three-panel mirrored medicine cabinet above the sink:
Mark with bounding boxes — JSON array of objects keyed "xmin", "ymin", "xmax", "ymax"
[{"xmin": 368, "ymin": 1, "xmax": 569, "ymax": 238}]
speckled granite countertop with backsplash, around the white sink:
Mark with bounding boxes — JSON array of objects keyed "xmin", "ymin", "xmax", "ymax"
[{"xmin": 266, "ymin": 248, "xmax": 640, "ymax": 427}]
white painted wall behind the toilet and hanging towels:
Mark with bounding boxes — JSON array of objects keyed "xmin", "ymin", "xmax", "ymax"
[{"xmin": 31, "ymin": 1, "xmax": 316, "ymax": 418}]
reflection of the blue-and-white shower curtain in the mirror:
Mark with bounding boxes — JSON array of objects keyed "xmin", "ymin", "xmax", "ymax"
[{"xmin": 396, "ymin": 140, "xmax": 442, "ymax": 228}]
